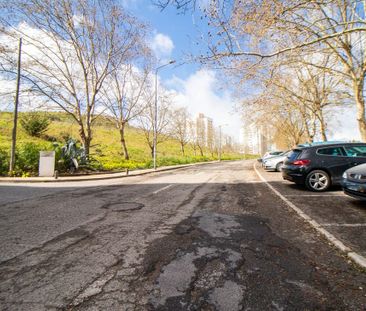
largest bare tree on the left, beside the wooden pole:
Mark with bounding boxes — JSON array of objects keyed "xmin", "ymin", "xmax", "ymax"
[{"xmin": 0, "ymin": 0, "xmax": 144, "ymax": 155}]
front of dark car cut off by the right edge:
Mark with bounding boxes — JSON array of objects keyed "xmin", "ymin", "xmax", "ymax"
[{"xmin": 342, "ymin": 164, "xmax": 366, "ymax": 201}]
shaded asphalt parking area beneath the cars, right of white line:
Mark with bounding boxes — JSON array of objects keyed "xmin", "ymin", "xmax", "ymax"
[{"xmin": 255, "ymin": 163, "xmax": 366, "ymax": 257}]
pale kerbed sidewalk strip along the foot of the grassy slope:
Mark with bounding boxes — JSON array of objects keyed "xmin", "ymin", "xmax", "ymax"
[{"xmin": 0, "ymin": 161, "xmax": 218, "ymax": 183}]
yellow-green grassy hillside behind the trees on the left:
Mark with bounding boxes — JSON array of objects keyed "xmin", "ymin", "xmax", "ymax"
[{"xmin": 0, "ymin": 112, "xmax": 254, "ymax": 174}]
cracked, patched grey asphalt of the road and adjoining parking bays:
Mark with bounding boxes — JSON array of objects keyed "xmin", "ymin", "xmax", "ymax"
[{"xmin": 0, "ymin": 161, "xmax": 366, "ymax": 311}]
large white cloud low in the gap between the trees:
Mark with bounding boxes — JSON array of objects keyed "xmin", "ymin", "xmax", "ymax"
[{"xmin": 165, "ymin": 70, "xmax": 242, "ymax": 141}]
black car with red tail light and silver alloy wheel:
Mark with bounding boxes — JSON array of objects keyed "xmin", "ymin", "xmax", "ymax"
[{"xmin": 282, "ymin": 143, "xmax": 366, "ymax": 191}]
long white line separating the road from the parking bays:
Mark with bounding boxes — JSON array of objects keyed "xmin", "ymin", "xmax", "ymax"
[{"xmin": 253, "ymin": 163, "xmax": 366, "ymax": 269}]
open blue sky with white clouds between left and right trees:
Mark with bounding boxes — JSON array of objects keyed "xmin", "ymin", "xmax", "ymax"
[{"xmin": 121, "ymin": 0, "xmax": 246, "ymax": 141}]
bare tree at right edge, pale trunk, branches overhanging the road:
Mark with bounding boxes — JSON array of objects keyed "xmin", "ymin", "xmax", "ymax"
[{"xmin": 158, "ymin": 0, "xmax": 366, "ymax": 140}]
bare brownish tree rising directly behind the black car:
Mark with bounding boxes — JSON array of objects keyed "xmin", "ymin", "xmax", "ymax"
[{"xmin": 266, "ymin": 55, "xmax": 345, "ymax": 142}]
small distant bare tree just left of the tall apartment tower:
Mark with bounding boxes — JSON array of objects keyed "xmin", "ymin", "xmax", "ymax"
[{"xmin": 171, "ymin": 107, "xmax": 190, "ymax": 156}]
